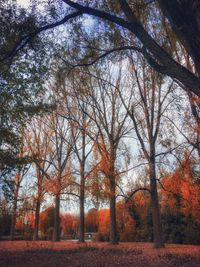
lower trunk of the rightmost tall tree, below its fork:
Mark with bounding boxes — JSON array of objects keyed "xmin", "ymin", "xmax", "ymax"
[{"xmin": 149, "ymin": 157, "xmax": 164, "ymax": 248}]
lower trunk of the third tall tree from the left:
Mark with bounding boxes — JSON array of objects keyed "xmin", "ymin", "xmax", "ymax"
[{"xmin": 53, "ymin": 193, "xmax": 60, "ymax": 242}]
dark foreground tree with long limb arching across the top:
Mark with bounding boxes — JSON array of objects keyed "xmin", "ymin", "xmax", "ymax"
[{"xmin": 3, "ymin": 0, "xmax": 200, "ymax": 96}]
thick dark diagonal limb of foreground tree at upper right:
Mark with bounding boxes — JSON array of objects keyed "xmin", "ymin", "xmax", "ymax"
[{"xmin": 63, "ymin": 0, "xmax": 200, "ymax": 96}]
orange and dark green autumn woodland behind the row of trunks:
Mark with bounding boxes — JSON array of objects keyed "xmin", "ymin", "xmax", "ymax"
[{"xmin": 1, "ymin": 157, "xmax": 200, "ymax": 247}]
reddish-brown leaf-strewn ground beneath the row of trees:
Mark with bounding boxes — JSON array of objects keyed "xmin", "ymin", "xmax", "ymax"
[{"xmin": 0, "ymin": 241, "xmax": 200, "ymax": 267}]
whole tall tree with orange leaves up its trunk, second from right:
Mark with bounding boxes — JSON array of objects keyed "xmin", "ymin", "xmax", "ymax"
[{"xmin": 74, "ymin": 64, "xmax": 130, "ymax": 244}]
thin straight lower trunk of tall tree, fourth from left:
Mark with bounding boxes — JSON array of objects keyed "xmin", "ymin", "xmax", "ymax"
[{"xmin": 79, "ymin": 171, "xmax": 85, "ymax": 243}]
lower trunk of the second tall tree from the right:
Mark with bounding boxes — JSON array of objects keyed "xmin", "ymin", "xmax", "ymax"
[{"xmin": 110, "ymin": 176, "xmax": 118, "ymax": 244}]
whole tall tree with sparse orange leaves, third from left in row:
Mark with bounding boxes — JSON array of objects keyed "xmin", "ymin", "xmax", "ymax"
[{"xmin": 35, "ymin": 110, "xmax": 72, "ymax": 241}]
